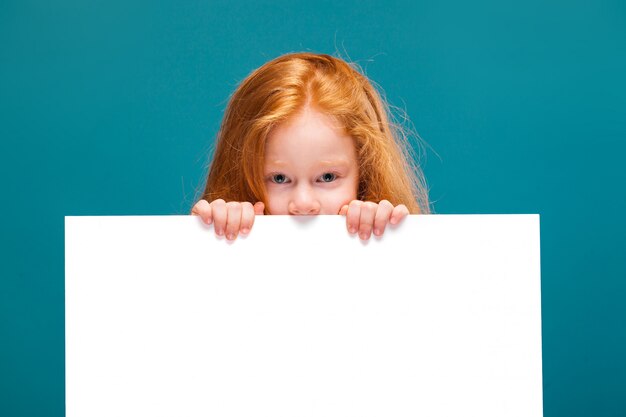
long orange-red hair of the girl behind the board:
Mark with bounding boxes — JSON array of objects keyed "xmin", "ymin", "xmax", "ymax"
[{"xmin": 202, "ymin": 53, "xmax": 430, "ymax": 214}]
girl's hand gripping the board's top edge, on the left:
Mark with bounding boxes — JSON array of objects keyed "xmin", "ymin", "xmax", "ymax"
[{"xmin": 191, "ymin": 199, "xmax": 265, "ymax": 240}]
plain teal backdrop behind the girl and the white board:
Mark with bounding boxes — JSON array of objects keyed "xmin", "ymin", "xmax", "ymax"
[{"xmin": 0, "ymin": 0, "xmax": 626, "ymax": 417}]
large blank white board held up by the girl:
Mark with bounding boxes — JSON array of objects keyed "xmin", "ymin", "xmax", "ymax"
[{"xmin": 65, "ymin": 215, "xmax": 542, "ymax": 417}]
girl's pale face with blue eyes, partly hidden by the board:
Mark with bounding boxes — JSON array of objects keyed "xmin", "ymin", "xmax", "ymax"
[{"xmin": 265, "ymin": 106, "xmax": 359, "ymax": 215}]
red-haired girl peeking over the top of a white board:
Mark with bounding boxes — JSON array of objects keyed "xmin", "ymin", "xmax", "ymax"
[{"xmin": 192, "ymin": 53, "xmax": 429, "ymax": 240}]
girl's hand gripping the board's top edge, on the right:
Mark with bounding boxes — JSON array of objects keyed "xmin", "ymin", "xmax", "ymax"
[{"xmin": 339, "ymin": 200, "xmax": 409, "ymax": 240}]
